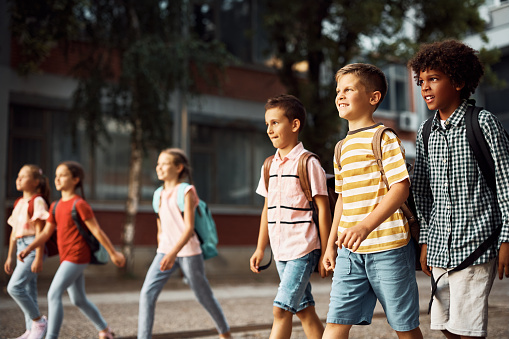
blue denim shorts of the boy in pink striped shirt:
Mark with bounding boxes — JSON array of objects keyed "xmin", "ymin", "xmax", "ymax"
[{"xmin": 273, "ymin": 250, "xmax": 321, "ymax": 314}]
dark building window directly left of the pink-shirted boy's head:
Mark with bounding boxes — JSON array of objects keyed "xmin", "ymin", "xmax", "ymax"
[{"xmin": 191, "ymin": 125, "xmax": 275, "ymax": 206}]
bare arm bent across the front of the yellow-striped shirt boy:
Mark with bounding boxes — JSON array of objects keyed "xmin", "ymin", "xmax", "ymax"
[{"xmin": 338, "ymin": 179, "xmax": 410, "ymax": 252}]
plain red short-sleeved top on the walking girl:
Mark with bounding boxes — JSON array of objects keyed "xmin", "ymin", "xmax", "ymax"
[{"xmin": 48, "ymin": 196, "xmax": 94, "ymax": 264}]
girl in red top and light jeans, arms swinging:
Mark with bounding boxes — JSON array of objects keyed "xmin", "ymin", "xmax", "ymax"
[{"xmin": 18, "ymin": 161, "xmax": 125, "ymax": 339}]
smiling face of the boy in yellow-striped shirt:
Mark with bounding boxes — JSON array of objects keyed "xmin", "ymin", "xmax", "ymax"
[{"xmin": 336, "ymin": 73, "xmax": 381, "ymax": 124}]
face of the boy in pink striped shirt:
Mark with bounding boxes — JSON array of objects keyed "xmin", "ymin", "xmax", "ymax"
[{"xmin": 265, "ymin": 107, "xmax": 300, "ymax": 157}]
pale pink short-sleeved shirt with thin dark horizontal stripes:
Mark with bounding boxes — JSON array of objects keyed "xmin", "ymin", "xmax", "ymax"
[{"xmin": 256, "ymin": 143, "xmax": 327, "ymax": 261}]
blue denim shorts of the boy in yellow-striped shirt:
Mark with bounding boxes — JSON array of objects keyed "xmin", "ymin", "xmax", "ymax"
[{"xmin": 327, "ymin": 241, "xmax": 419, "ymax": 332}]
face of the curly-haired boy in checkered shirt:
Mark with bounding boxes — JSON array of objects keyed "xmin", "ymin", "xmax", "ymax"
[{"xmin": 418, "ymin": 69, "xmax": 463, "ymax": 120}]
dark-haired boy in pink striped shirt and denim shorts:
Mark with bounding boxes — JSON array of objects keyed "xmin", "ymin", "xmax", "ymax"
[{"xmin": 250, "ymin": 95, "xmax": 331, "ymax": 339}]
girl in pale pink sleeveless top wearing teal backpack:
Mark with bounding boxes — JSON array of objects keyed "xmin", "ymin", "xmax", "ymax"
[{"xmin": 138, "ymin": 148, "xmax": 231, "ymax": 339}]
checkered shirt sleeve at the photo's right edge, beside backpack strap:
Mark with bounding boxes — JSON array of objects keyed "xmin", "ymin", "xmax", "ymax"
[{"xmin": 479, "ymin": 110, "xmax": 509, "ymax": 242}]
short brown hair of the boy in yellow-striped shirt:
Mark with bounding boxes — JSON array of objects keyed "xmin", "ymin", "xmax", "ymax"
[{"xmin": 336, "ymin": 63, "xmax": 388, "ymax": 110}]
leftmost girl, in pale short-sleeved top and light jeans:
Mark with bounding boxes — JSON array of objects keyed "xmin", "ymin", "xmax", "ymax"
[{"xmin": 4, "ymin": 165, "xmax": 49, "ymax": 339}]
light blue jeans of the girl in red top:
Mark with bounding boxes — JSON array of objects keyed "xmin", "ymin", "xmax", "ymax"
[{"xmin": 46, "ymin": 261, "xmax": 108, "ymax": 339}]
